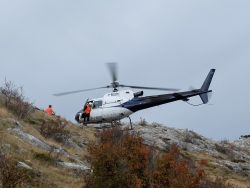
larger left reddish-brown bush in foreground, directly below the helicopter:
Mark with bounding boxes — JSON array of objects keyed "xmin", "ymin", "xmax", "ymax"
[{"xmin": 86, "ymin": 127, "xmax": 150, "ymax": 187}]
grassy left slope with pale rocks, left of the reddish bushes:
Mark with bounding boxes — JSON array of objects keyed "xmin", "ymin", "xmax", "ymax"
[{"xmin": 0, "ymin": 100, "xmax": 95, "ymax": 187}]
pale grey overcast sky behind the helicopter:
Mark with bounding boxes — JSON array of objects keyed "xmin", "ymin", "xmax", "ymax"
[{"xmin": 0, "ymin": 0, "xmax": 250, "ymax": 140}]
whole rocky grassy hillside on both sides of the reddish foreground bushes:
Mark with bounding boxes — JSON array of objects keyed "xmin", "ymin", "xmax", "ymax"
[{"xmin": 0, "ymin": 100, "xmax": 250, "ymax": 188}]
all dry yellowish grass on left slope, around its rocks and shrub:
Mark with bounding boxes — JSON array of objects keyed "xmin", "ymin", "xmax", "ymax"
[{"xmin": 0, "ymin": 106, "xmax": 96, "ymax": 188}]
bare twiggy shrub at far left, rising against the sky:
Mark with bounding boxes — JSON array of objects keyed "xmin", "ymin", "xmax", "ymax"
[{"xmin": 0, "ymin": 80, "xmax": 33, "ymax": 119}]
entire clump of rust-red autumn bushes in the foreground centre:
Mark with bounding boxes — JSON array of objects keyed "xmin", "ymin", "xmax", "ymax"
[{"xmin": 85, "ymin": 127, "xmax": 205, "ymax": 188}]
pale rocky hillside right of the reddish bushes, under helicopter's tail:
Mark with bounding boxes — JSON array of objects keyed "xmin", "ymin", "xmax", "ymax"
[{"xmin": 126, "ymin": 123, "xmax": 250, "ymax": 188}]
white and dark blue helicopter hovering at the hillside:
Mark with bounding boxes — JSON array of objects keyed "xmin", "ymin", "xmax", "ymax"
[{"xmin": 54, "ymin": 63, "xmax": 215, "ymax": 126}]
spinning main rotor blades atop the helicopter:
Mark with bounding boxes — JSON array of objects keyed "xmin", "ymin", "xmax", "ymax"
[{"xmin": 53, "ymin": 62, "xmax": 178, "ymax": 96}]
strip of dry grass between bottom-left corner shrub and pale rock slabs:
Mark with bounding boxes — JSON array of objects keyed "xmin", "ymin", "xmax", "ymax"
[{"xmin": 0, "ymin": 135, "xmax": 86, "ymax": 188}]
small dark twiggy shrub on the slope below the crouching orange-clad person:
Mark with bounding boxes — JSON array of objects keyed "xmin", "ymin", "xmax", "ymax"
[{"xmin": 40, "ymin": 119, "xmax": 70, "ymax": 143}]
